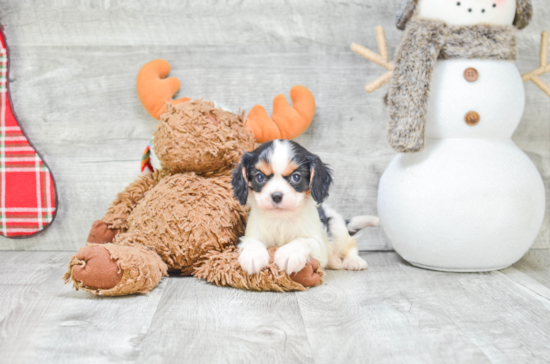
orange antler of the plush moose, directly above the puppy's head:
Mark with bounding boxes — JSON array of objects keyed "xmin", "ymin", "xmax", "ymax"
[{"xmin": 246, "ymin": 86, "xmax": 315, "ymax": 143}]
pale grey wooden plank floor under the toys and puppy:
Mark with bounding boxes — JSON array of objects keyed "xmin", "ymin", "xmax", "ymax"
[{"xmin": 0, "ymin": 250, "xmax": 550, "ymax": 364}]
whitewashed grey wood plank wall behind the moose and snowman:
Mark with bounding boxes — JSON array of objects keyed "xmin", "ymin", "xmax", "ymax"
[{"xmin": 0, "ymin": 0, "xmax": 550, "ymax": 250}]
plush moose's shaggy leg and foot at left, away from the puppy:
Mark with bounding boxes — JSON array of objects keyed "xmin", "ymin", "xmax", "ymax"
[{"xmin": 63, "ymin": 243, "xmax": 168, "ymax": 296}]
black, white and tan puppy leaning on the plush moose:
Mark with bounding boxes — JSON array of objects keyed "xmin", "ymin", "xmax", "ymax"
[{"xmin": 232, "ymin": 140, "xmax": 379, "ymax": 274}]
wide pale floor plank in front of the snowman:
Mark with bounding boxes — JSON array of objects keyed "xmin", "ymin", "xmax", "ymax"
[{"xmin": 298, "ymin": 253, "xmax": 550, "ymax": 363}]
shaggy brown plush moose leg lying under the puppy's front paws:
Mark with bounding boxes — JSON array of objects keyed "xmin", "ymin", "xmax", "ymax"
[{"xmin": 194, "ymin": 247, "xmax": 324, "ymax": 292}]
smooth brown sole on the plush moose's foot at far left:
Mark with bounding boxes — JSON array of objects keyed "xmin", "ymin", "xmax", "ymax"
[{"xmin": 72, "ymin": 245, "xmax": 124, "ymax": 289}]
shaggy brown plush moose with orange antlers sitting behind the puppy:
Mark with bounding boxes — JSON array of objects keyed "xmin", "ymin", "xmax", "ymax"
[{"xmin": 64, "ymin": 60, "xmax": 323, "ymax": 296}]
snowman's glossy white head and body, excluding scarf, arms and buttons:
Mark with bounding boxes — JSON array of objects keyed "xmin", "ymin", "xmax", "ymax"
[{"xmin": 378, "ymin": 0, "xmax": 546, "ymax": 271}]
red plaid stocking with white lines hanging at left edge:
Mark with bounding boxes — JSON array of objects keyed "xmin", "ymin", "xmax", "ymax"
[{"xmin": 0, "ymin": 27, "xmax": 57, "ymax": 238}]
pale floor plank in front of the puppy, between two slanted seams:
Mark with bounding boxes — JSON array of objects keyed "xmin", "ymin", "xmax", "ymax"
[{"xmin": 138, "ymin": 277, "xmax": 313, "ymax": 363}]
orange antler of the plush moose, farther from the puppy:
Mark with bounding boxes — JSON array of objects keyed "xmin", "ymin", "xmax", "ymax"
[{"xmin": 137, "ymin": 59, "xmax": 190, "ymax": 120}]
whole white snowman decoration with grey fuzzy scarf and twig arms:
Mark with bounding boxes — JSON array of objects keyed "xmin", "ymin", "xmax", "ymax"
[{"xmin": 352, "ymin": 0, "xmax": 550, "ymax": 271}]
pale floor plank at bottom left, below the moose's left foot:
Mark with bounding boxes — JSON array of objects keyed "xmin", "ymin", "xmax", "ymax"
[{"xmin": 0, "ymin": 252, "xmax": 167, "ymax": 363}]
